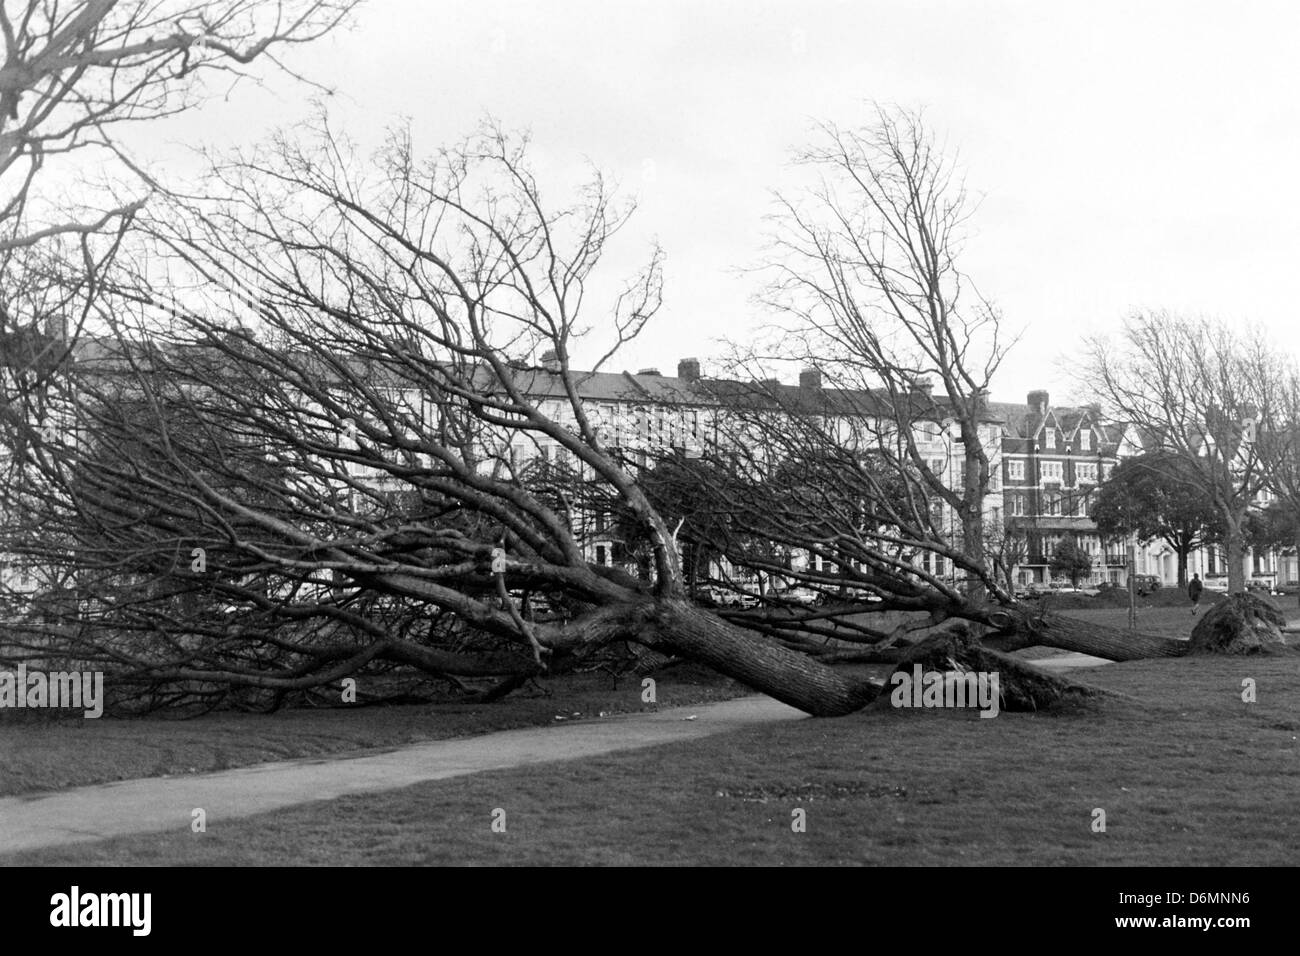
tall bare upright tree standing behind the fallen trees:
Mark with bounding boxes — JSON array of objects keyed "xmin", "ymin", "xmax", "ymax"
[{"xmin": 763, "ymin": 107, "xmax": 1009, "ymax": 598}]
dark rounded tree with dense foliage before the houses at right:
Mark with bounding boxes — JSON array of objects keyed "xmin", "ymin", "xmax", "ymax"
[{"xmin": 1089, "ymin": 451, "xmax": 1222, "ymax": 588}]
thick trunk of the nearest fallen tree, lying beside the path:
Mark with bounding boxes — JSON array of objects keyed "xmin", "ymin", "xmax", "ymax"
[{"xmin": 634, "ymin": 601, "xmax": 880, "ymax": 717}]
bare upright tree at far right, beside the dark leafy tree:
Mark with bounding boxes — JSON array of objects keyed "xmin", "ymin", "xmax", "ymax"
[{"xmin": 1080, "ymin": 312, "xmax": 1283, "ymax": 593}]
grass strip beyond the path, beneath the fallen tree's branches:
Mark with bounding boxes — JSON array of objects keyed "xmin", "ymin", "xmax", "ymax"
[{"xmin": 0, "ymin": 667, "xmax": 750, "ymax": 796}]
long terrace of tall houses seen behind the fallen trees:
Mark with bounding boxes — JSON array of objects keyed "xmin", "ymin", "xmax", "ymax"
[{"xmin": 0, "ymin": 330, "xmax": 1279, "ymax": 598}]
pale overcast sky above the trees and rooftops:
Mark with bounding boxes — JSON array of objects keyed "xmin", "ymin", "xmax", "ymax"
[{"xmin": 126, "ymin": 0, "xmax": 1300, "ymax": 401}]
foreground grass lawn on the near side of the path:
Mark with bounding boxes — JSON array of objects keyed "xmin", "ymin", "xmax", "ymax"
[{"xmin": 4, "ymin": 609, "xmax": 1300, "ymax": 866}]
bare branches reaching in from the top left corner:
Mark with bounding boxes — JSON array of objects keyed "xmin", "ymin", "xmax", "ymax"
[{"xmin": 0, "ymin": 0, "xmax": 356, "ymax": 251}]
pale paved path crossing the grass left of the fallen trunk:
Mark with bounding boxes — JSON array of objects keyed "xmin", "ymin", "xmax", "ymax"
[{"xmin": 0, "ymin": 697, "xmax": 805, "ymax": 853}]
